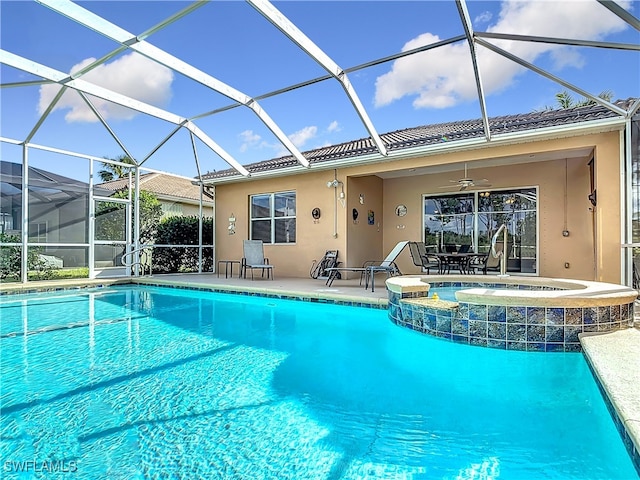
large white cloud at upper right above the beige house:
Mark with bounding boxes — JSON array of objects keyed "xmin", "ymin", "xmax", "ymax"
[{"xmin": 375, "ymin": 0, "xmax": 629, "ymax": 108}]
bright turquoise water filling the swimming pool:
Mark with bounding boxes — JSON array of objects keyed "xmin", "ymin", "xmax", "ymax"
[{"xmin": 0, "ymin": 286, "xmax": 638, "ymax": 480}]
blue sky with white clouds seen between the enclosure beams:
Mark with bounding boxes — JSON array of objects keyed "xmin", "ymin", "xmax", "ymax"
[{"xmin": 0, "ymin": 0, "xmax": 640, "ymax": 179}]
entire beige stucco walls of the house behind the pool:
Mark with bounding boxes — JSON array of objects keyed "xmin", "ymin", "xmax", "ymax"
[{"xmin": 216, "ymin": 131, "xmax": 621, "ymax": 283}]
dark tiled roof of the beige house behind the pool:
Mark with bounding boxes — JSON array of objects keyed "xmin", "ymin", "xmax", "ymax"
[{"xmin": 202, "ymin": 99, "xmax": 635, "ymax": 180}]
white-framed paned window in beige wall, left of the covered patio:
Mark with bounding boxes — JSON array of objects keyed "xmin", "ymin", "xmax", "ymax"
[{"xmin": 249, "ymin": 192, "xmax": 296, "ymax": 243}]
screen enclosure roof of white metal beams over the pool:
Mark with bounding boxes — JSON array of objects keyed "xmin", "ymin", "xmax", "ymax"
[{"xmin": 0, "ymin": 0, "xmax": 640, "ymax": 183}]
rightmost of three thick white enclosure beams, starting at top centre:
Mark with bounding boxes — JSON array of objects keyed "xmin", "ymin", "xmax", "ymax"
[{"xmin": 247, "ymin": 0, "xmax": 387, "ymax": 155}]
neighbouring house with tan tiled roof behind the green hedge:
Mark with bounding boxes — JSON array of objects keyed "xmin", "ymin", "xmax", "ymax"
[{"xmin": 98, "ymin": 172, "xmax": 213, "ymax": 218}]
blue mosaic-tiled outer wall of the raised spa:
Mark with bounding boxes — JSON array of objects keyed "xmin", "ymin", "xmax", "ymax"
[{"xmin": 389, "ymin": 284, "xmax": 633, "ymax": 352}]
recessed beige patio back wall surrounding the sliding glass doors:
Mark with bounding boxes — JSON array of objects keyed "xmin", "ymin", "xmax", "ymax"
[{"xmin": 385, "ymin": 158, "xmax": 594, "ymax": 280}]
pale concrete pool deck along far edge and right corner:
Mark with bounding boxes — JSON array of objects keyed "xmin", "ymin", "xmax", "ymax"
[{"xmin": 0, "ymin": 274, "xmax": 640, "ymax": 473}]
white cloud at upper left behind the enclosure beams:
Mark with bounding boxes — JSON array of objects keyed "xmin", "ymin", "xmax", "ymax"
[{"xmin": 38, "ymin": 53, "xmax": 173, "ymax": 122}]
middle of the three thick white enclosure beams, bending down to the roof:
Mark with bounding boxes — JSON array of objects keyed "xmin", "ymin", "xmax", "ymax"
[{"xmin": 38, "ymin": 0, "xmax": 309, "ymax": 167}]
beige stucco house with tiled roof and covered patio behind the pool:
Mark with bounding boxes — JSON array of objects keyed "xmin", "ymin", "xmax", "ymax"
[{"xmin": 208, "ymin": 99, "xmax": 640, "ymax": 283}]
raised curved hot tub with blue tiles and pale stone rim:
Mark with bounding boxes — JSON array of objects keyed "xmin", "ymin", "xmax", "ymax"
[{"xmin": 387, "ymin": 275, "xmax": 637, "ymax": 352}]
